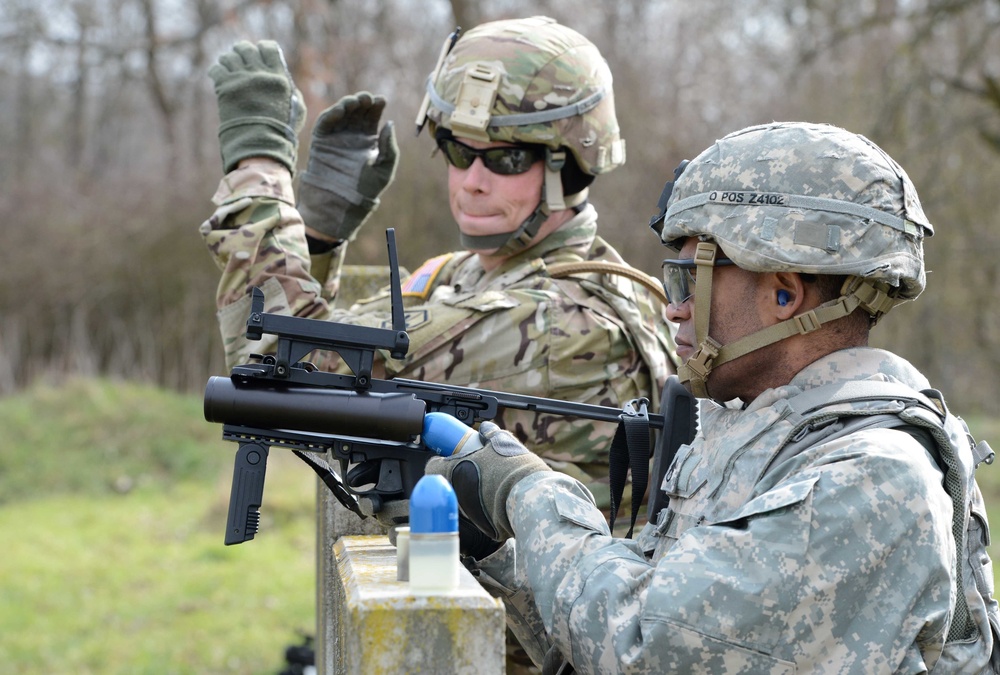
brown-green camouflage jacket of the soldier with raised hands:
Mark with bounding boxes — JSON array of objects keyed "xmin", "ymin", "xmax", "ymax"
[{"xmin": 201, "ymin": 164, "xmax": 673, "ymax": 507}]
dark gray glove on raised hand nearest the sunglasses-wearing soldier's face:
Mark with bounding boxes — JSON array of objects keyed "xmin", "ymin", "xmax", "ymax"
[{"xmin": 298, "ymin": 91, "xmax": 399, "ymax": 241}]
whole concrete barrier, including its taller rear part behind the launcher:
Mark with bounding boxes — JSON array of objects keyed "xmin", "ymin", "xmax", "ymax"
[{"xmin": 315, "ymin": 266, "xmax": 506, "ymax": 675}]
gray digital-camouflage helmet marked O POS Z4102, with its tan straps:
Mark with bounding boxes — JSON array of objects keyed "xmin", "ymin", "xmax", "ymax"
[{"xmin": 650, "ymin": 122, "xmax": 934, "ymax": 396}]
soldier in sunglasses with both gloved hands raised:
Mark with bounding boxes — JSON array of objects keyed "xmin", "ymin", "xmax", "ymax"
[{"xmin": 201, "ymin": 17, "xmax": 672, "ymax": 524}]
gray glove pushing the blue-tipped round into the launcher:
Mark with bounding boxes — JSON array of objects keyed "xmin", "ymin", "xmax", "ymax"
[{"xmin": 424, "ymin": 422, "xmax": 552, "ymax": 542}]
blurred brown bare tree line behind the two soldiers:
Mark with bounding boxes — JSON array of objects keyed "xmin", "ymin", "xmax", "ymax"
[{"xmin": 0, "ymin": 0, "xmax": 1000, "ymax": 412}]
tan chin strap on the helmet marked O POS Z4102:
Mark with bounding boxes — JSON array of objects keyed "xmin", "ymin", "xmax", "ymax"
[{"xmin": 677, "ymin": 241, "xmax": 905, "ymax": 398}]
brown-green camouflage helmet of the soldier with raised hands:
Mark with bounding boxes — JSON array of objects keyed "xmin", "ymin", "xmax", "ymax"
[{"xmin": 417, "ymin": 16, "xmax": 625, "ymax": 256}]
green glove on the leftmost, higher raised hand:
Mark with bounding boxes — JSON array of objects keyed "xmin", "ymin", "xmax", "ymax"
[{"xmin": 208, "ymin": 40, "xmax": 306, "ymax": 174}]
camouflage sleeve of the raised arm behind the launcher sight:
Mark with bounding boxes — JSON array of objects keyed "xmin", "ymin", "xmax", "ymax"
[{"xmin": 200, "ymin": 162, "xmax": 346, "ymax": 368}]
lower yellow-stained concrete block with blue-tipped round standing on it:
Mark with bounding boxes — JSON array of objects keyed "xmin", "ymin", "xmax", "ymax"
[{"xmin": 330, "ymin": 536, "xmax": 505, "ymax": 675}]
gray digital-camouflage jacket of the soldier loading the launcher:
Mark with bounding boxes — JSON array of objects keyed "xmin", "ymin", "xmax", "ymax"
[{"xmin": 477, "ymin": 348, "xmax": 997, "ymax": 674}]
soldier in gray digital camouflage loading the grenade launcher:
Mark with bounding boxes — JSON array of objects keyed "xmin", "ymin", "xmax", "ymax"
[{"xmin": 427, "ymin": 123, "xmax": 1000, "ymax": 674}]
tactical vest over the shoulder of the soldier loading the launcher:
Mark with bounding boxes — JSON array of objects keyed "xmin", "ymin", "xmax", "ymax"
[{"xmin": 657, "ymin": 380, "xmax": 1000, "ymax": 673}]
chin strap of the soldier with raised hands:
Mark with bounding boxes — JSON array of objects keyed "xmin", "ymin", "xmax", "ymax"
[{"xmin": 459, "ymin": 148, "xmax": 590, "ymax": 255}]
